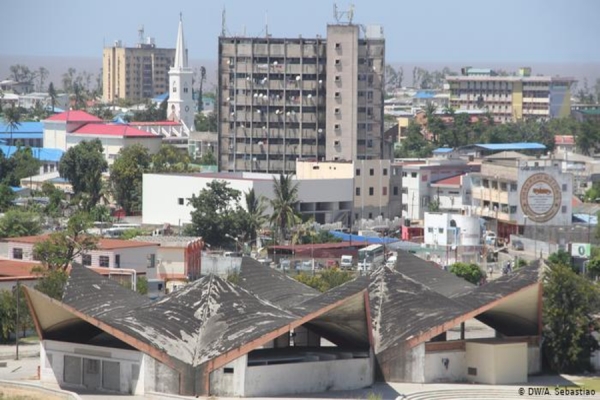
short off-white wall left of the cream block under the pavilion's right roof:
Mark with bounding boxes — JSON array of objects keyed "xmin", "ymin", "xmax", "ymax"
[{"xmin": 425, "ymin": 350, "xmax": 467, "ymax": 383}]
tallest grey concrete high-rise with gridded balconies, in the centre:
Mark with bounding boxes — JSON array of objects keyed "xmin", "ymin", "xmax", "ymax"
[{"xmin": 217, "ymin": 23, "xmax": 385, "ymax": 173}]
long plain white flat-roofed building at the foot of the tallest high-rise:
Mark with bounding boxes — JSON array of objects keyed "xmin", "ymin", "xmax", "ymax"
[{"xmin": 142, "ymin": 172, "xmax": 353, "ymax": 226}]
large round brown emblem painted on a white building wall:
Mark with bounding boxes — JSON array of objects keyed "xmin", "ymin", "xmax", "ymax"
[{"xmin": 520, "ymin": 173, "xmax": 562, "ymax": 222}]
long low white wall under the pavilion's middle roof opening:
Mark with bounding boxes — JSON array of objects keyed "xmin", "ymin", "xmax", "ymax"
[{"xmin": 243, "ymin": 358, "xmax": 374, "ymax": 397}]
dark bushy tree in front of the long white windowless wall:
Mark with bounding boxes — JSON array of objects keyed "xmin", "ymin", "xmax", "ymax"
[{"xmin": 185, "ymin": 180, "xmax": 246, "ymax": 246}]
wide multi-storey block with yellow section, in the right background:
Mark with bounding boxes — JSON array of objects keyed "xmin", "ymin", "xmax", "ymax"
[{"xmin": 446, "ymin": 67, "xmax": 575, "ymax": 122}]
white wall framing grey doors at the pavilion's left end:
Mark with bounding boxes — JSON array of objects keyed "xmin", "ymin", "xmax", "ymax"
[{"xmin": 40, "ymin": 340, "xmax": 144, "ymax": 395}]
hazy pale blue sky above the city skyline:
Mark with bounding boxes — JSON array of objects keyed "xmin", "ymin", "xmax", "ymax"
[{"xmin": 0, "ymin": 0, "xmax": 600, "ymax": 63}]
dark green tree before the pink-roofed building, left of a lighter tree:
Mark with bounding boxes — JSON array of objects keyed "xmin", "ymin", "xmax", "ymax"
[{"xmin": 58, "ymin": 139, "xmax": 108, "ymax": 211}]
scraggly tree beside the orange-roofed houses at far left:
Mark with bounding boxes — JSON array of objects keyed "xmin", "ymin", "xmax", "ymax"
[{"xmin": 33, "ymin": 211, "xmax": 98, "ymax": 271}]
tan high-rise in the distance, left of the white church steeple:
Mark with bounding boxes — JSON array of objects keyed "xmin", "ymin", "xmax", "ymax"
[{"xmin": 102, "ymin": 28, "xmax": 175, "ymax": 102}]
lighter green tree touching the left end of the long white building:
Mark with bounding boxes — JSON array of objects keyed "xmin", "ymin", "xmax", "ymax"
[{"xmin": 110, "ymin": 144, "xmax": 150, "ymax": 215}]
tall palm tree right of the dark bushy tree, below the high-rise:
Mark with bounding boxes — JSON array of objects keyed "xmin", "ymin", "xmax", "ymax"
[{"xmin": 270, "ymin": 174, "xmax": 300, "ymax": 244}]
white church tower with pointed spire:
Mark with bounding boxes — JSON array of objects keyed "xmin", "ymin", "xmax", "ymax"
[{"xmin": 167, "ymin": 14, "xmax": 195, "ymax": 131}]
